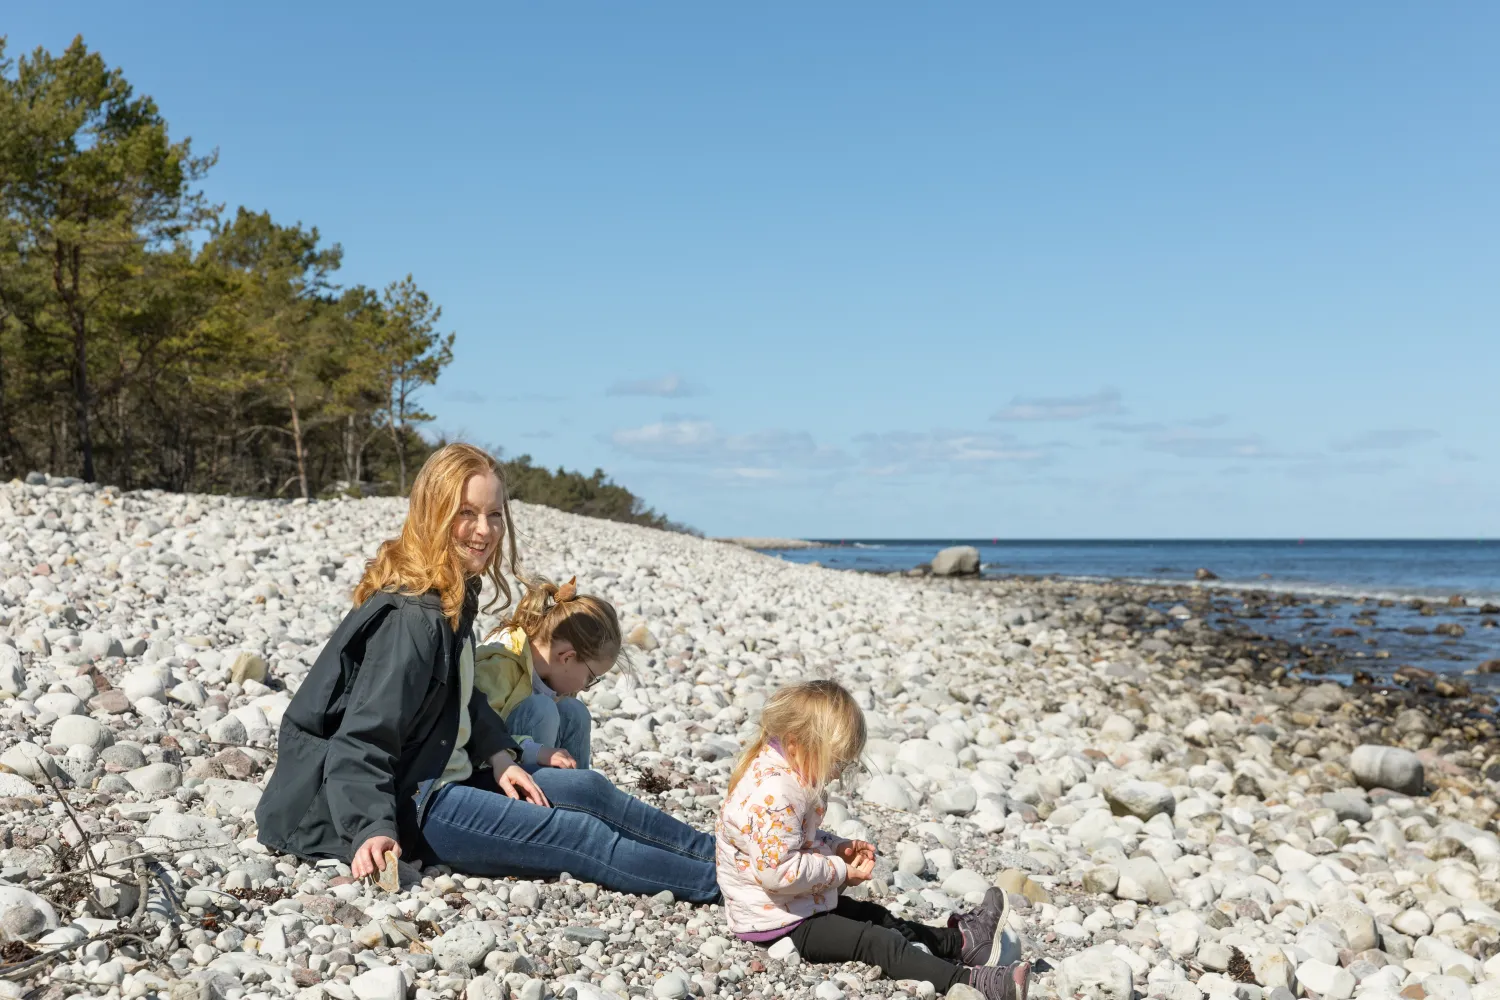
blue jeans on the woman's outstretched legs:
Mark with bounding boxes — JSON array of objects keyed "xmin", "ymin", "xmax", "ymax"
[{"xmin": 422, "ymin": 768, "xmax": 719, "ymax": 903}]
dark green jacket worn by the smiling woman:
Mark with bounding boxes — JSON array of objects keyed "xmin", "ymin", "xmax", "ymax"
[{"xmin": 255, "ymin": 586, "xmax": 519, "ymax": 861}]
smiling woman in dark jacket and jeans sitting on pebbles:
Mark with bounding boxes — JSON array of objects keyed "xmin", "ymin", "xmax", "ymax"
[{"xmin": 255, "ymin": 444, "xmax": 719, "ymax": 903}]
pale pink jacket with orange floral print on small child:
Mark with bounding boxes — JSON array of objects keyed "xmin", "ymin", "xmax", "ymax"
[{"xmin": 714, "ymin": 747, "xmax": 849, "ymax": 934}]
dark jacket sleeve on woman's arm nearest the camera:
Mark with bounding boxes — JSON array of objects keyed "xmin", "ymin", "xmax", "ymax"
[{"xmin": 324, "ymin": 607, "xmax": 441, "ymax": 850}]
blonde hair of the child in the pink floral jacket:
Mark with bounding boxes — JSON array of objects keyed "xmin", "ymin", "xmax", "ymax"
[{"xmin": 729, "ymin": 681, "xmax": 866, "ymax": 792}]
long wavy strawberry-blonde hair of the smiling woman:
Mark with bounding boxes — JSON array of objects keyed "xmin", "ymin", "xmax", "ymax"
[{"xmin": 354, "ymin": 444, "xmax": 521, "ymax": 630}]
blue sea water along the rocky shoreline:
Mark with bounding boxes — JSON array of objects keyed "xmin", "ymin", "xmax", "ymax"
[{"xmin": 756, "ymin": 538, "xmax": 1500, "ymax": 691}]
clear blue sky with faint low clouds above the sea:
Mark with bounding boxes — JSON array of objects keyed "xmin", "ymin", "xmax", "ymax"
[{"xmin": 0, "ymin": 3, "xmax": 1500, "ymax": 537}]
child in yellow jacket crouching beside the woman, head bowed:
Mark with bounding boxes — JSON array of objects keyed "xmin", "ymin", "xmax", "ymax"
[{"xmin": 474, "ymin": 577, "xmax": 621, "ymax": 768}]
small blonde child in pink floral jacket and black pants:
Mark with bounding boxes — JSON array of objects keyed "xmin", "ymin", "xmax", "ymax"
[{"xmin": 716, "ymin": 681, "xmax": 1031, "ymax": 1000}]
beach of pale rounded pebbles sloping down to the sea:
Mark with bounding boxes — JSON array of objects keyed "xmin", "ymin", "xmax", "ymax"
[{"xmin": 0, "ymin": 475, "xmax": 1500, "ymax": 1000}]
